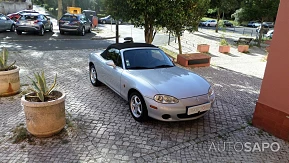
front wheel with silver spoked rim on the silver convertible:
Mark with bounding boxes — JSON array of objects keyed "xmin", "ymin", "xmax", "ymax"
[{"xmin": 129, "ymin": 92, "xmax": 148, "ymax": 122}]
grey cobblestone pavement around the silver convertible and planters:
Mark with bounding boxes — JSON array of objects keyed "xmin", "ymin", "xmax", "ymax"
[{"xmin": 0, "ymin": 47, "xmax": 289, "ymax": 162}]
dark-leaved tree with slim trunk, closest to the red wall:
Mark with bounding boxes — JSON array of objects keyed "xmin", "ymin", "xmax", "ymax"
[{"xmin": 241, "ymin": 0, "xmax": 280, "ymax": 46}]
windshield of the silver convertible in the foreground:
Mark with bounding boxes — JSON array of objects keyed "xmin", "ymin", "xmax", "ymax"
[{"xmin": 123, "ymin": 49, "xmax": 174, "ymax": 69}]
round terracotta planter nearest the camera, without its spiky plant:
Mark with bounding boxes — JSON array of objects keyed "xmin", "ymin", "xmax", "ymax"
[{"xmin": 21, "ymin": 91, "xmax": 66, "ymax": 137}]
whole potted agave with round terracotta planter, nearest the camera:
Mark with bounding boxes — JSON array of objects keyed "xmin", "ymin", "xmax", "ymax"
[{"xmin": 21, "ymin": 71, "xmax": 66, "ymax": 137}]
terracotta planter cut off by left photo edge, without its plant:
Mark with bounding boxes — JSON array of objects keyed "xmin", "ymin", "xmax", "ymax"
[{"xmin": 0, "ymin": 67, "xmax": 20, "ymax": 97}]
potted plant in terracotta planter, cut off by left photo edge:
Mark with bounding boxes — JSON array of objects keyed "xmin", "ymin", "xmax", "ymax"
[{"xmin": 0, "ymin": 48, "xmax": 20, "ymax": 97}]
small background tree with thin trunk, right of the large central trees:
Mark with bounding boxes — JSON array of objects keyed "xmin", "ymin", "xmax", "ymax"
[{"xmin": 211, "ymin": 0, "xmax": 239, "ymax": 33}]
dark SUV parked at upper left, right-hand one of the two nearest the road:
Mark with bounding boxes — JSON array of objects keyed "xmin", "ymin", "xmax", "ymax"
[{"xmin": 59, "ymin": 13, "xmax": 92, "ymax": 36}]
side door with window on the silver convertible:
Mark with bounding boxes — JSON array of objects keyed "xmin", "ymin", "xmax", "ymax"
[{"xmin": 107, "ymin": 48, "xmax": 123, "ymax": 94}]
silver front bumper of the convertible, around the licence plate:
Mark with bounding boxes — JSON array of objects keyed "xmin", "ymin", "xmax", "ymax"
[{"xmin": 144, "ymin": 95, "xmax": 215, "ymax": 121}]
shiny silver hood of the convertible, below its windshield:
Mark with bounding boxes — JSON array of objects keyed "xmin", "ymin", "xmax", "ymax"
[{"xmin": 129, "ymin": 67, "xmax": 210, "ymax": 99}]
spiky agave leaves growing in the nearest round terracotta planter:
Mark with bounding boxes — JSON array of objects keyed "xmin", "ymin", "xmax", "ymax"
[{"xmin": 28, "ymin": 71, "xmax": 57, "ymax": 102}]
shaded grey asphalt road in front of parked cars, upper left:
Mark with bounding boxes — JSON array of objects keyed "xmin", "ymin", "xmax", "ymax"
[{"xmin": 0, "ymin": 31, "xmax": 113, "ymax": 51}]
